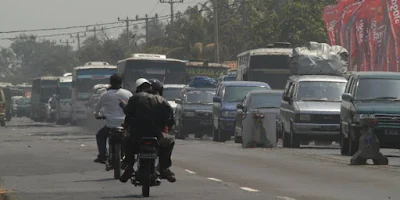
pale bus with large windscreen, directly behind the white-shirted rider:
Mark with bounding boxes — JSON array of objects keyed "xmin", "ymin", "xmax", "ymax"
[{"xmin": 72, "ymin": 62, "xmax": 117, "ymax": 124}]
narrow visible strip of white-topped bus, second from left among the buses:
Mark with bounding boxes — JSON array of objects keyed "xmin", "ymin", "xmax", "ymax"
[{"xmin": 56, "ymin": 74, "xmax": 72, "ymax": 124}]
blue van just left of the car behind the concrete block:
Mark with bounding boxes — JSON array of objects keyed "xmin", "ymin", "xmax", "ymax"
[{"xmin": 213, "ymin": 81, "xmax": 271, "ymax": 142}]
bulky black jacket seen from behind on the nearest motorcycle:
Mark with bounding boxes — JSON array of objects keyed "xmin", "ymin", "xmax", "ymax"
[{"xmin": 124, "ymin": 92, "xmax": 174, "ymax": 138}]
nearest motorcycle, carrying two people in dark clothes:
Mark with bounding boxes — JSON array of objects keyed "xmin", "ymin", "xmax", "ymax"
[{"xmin": 131, "ymin": 137, "xmax": 161, "ymax": 197}]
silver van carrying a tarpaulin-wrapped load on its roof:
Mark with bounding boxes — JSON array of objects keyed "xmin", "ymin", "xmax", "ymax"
[{"xmin": 280, "ymin": 75, "xmax": 347, "ymax": 148}]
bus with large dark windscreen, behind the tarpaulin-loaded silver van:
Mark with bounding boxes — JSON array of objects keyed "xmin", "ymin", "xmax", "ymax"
[{"xmin": 236, "ymin": 43, "xmax": 292, "ymax": 89}]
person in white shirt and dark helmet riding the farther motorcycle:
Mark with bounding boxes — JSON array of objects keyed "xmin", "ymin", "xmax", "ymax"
[{"xmin": 94, "ymin": 74, "xmax": 132, "ymax": 164}]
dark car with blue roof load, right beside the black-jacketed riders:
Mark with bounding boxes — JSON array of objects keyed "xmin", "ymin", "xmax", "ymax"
[{"xmin": 175, "ymin": 87, "xmax": 215, "ymax": 139}]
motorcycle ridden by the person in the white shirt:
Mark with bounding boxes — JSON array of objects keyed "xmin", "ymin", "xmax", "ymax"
[{"xmin": 97, "ymin": 116, "xmax": 125, "ymax": 179}]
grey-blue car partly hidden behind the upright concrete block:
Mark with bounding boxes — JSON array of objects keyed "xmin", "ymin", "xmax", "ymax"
[{"xmin": 235, "ymin": 90, "xmax": 283, "ymax": 147}]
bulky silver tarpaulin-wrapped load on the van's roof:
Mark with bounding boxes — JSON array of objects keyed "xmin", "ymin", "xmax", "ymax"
[{"xmin": 289, "ymin": 42, "xmax": 349, "ymax": 76}]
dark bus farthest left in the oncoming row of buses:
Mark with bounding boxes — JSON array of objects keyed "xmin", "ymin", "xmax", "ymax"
[{"xmin": 31, "ymin": 76, "xmax": 59, "ymax": 121}]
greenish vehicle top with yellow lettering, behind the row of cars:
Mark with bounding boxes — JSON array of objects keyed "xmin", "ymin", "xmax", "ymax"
[{"xmin": 185, "ymin": 60, "xmax": 230, "ymax": 80}]
